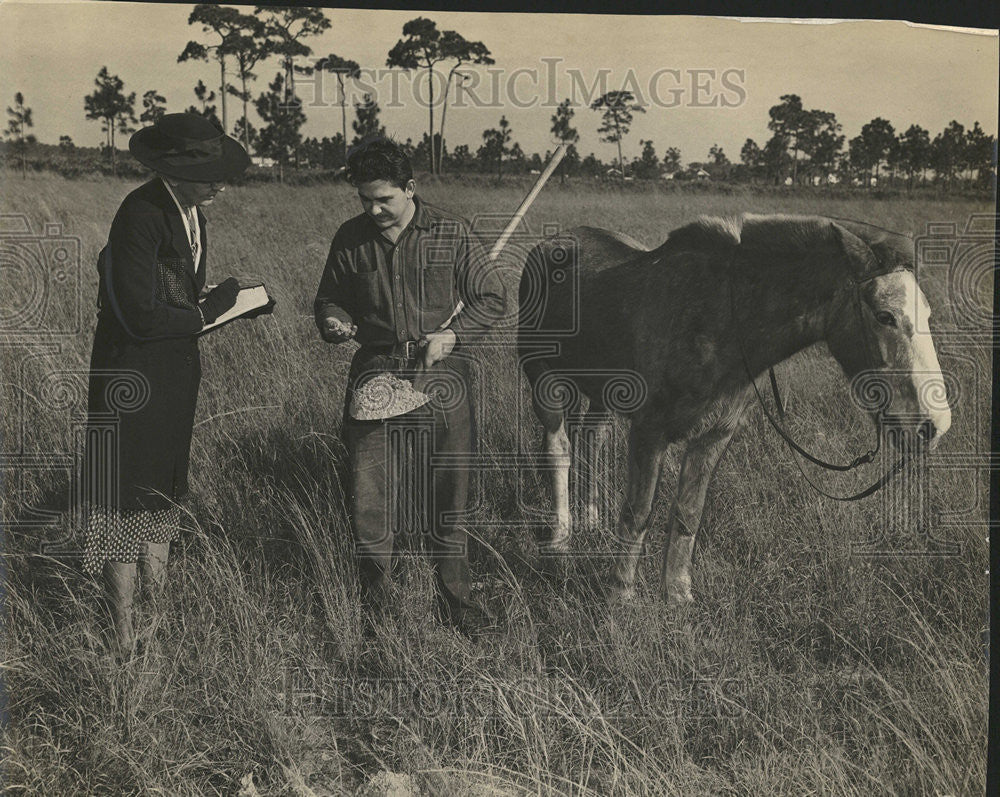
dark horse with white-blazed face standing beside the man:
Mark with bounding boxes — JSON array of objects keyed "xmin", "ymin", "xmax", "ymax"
[{"xmin": 517, "ymin": 214, "xmax": 951, "ymax": 604}]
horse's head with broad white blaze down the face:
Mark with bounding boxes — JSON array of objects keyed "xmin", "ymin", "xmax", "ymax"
[{"xmin": 827, "ymin": 222, "xmax": 951, "ymax": 449}]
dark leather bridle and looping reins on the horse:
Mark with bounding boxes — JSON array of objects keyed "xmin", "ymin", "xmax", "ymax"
[{"xmin": 729, "ymin": 216, "xmax": 912, "ymax": 501}]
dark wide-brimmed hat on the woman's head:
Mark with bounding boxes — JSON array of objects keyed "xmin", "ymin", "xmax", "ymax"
[{"xmin": 128, "ymin": 113, "xmax": 250, "ymax": 183}]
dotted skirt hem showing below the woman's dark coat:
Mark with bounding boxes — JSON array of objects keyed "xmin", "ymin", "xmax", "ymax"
[{"xmin": 83, "ymin": 506, "xmax": 181, "ymax": 575}]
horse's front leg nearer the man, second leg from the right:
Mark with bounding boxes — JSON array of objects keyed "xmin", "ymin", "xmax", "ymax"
[{"xmin": 610, "ymin": 420, "xmax": 664, "ymax": 599}]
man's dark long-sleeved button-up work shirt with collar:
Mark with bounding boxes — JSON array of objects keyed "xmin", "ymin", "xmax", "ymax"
[{"xmin": 315, "ymin": 196, "xmax": 506, "ymax": 346}]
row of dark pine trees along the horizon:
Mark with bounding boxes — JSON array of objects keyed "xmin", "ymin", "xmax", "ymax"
[{"xmin": 5, "ymin": 3, "xmax": 996, "ymax": 187}]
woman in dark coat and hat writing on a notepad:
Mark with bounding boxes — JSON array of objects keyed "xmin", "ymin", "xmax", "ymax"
[{"xmin": 83, "ymin": 113, "xmax": 250, "ymax": 653}]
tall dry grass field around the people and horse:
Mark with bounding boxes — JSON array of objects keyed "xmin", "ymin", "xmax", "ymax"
[{"xmin": 0, "ymin": 171, "xmax": 992, "ymax": 795}]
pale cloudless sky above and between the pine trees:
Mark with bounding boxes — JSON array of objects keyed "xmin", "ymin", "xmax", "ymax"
[{"xmin": 0, "ymin": 0, "xmax": 998, "ymax": 163}]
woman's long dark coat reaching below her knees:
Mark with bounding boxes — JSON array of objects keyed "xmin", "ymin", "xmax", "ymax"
[{"xmin": 83, "ymin": 178, "xmax": 207, "ymax": 510}]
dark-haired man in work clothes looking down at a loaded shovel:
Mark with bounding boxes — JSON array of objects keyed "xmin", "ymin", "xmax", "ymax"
[{"xmin": 315, "ymin": 138, "xmax": 505, "ymax": 634}]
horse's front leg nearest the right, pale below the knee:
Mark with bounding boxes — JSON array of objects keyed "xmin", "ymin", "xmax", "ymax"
[{"xmin": 660, "ymin": 424, "xmax": 738, "ymax": 604}]
